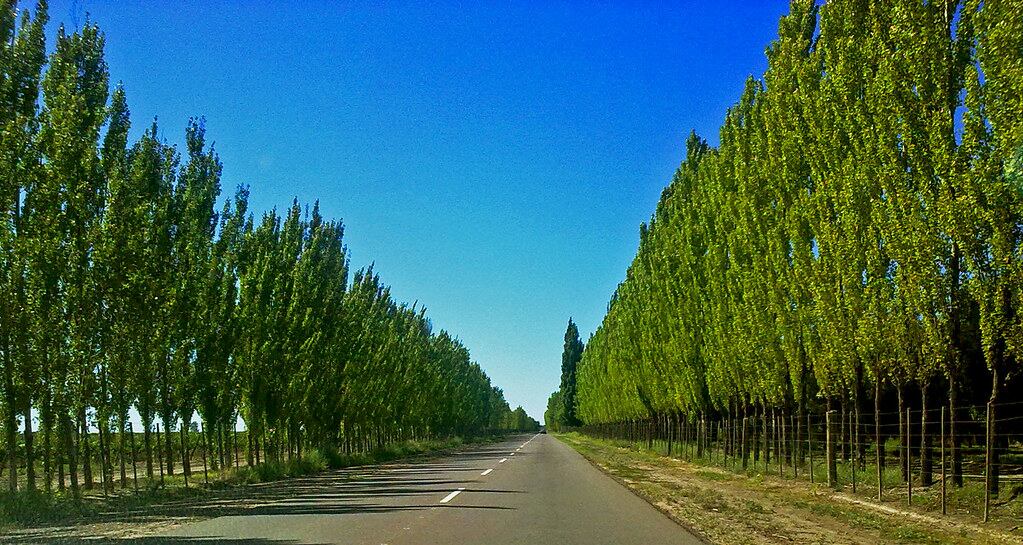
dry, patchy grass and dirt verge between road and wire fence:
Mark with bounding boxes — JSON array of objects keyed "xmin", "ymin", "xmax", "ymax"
[{"xmin": 559, "ymin": 434, "xmax": 1023, "ymax": 545}]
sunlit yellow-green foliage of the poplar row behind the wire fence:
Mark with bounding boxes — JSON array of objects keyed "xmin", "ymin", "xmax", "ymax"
[{"xmin": 562, "ymin": 0, "xmax": 1023, "ymax": 487}]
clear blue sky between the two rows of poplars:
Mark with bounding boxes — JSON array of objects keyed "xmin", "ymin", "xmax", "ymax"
[{"xmin": 50, "ymin": 0, "xmax": 788, "ymax": 419}]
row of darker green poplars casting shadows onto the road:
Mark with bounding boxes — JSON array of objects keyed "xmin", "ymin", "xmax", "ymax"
[{"xmin": 0, "ymin": 0, "xmax": 538, "ymax": 496}]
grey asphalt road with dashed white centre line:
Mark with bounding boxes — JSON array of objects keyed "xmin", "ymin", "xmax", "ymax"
[{"xmin": 152, "ymin": 435, "xmax": 702, "ymax": 545}]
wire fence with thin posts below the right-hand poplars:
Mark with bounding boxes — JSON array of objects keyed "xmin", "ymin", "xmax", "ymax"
[{"xmin": 581, "ymin": 402, "xmax": 1023, "ymax": 523}]
